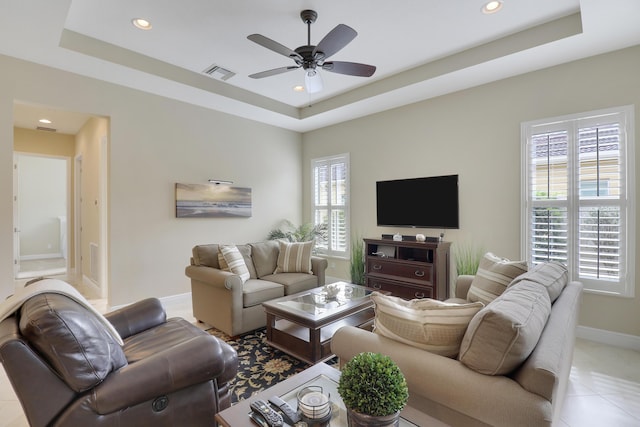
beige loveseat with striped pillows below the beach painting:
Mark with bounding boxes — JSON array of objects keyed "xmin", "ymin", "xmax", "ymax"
[{"xmin": 185, "ymin": 240, "xmax": 327, "ymax": 336}]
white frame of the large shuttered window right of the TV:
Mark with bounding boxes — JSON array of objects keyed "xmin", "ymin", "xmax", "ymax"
[{"xmin": 521, "ymin": 105, "xmax": 636, "ymax": 297}]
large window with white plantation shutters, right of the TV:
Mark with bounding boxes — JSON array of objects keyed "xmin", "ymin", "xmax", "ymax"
[{"xmin": 522, "ymin": 107, "xmax": 635, "ymax": 296}]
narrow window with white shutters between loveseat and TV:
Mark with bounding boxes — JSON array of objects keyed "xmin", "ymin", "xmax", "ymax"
[{"xmin": 311, "ymin": 154, "xmax": 350, "ymax": 257}]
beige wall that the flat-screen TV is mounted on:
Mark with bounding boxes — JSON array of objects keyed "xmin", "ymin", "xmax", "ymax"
[{"xmin": 303, "ymin": 47, "xmax": 640, "ymax": 336}]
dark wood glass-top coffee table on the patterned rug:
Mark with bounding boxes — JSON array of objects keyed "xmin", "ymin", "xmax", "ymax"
[{"xmin": 262, "ymin": 282, "xmax": 375, "ymax": 364}]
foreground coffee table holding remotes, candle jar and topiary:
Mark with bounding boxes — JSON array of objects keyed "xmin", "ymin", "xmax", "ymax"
[{"xmin": 216, "ymin": 363, "xmax": 446, "ymax": 427}]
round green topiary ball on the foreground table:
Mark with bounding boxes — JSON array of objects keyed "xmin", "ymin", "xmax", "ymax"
[{"xmin": 338, "ymin": 352, "xmax": 409, "ymax": 417}]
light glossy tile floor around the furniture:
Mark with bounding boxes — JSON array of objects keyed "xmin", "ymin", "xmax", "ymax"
[{"xmin": 0, "ymin": 300, "xmax": 640, "ymax": 427}]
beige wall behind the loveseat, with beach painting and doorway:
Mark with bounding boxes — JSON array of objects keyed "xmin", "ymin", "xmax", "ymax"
[{"xmin": 0, "ymin": 56, "xmax": 302, "ymax": 305}]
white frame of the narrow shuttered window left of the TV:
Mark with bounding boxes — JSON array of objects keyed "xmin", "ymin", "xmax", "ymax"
[{"xmin": 311, "ymin": 153, "xmax": 351, "ymax": 259}]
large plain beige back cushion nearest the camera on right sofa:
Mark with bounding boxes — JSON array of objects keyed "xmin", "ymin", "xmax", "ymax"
[{"xmin": 458, "ymin": 281, "xmax": 551, "ymax": 375}]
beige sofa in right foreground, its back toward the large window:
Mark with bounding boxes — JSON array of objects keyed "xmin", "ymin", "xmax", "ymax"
[{"xmin": 331, "ymin": 262, "xmax": 582, "ymax": 427}]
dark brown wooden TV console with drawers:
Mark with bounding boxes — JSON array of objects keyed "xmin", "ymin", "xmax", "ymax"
[{"xmin": 364, "ymin": 239, "xmax": 451, "ymax": 300}]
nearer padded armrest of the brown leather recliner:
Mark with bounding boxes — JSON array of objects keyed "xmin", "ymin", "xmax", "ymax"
[{"xmin": 91, "ymin": 335, "xmax": 230, "ymax": 414}]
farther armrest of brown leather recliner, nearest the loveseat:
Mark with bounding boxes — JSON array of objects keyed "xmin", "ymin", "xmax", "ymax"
[{"xmin": 104, "ymin": 298, "xmax": 167, "ymax": 339}]
